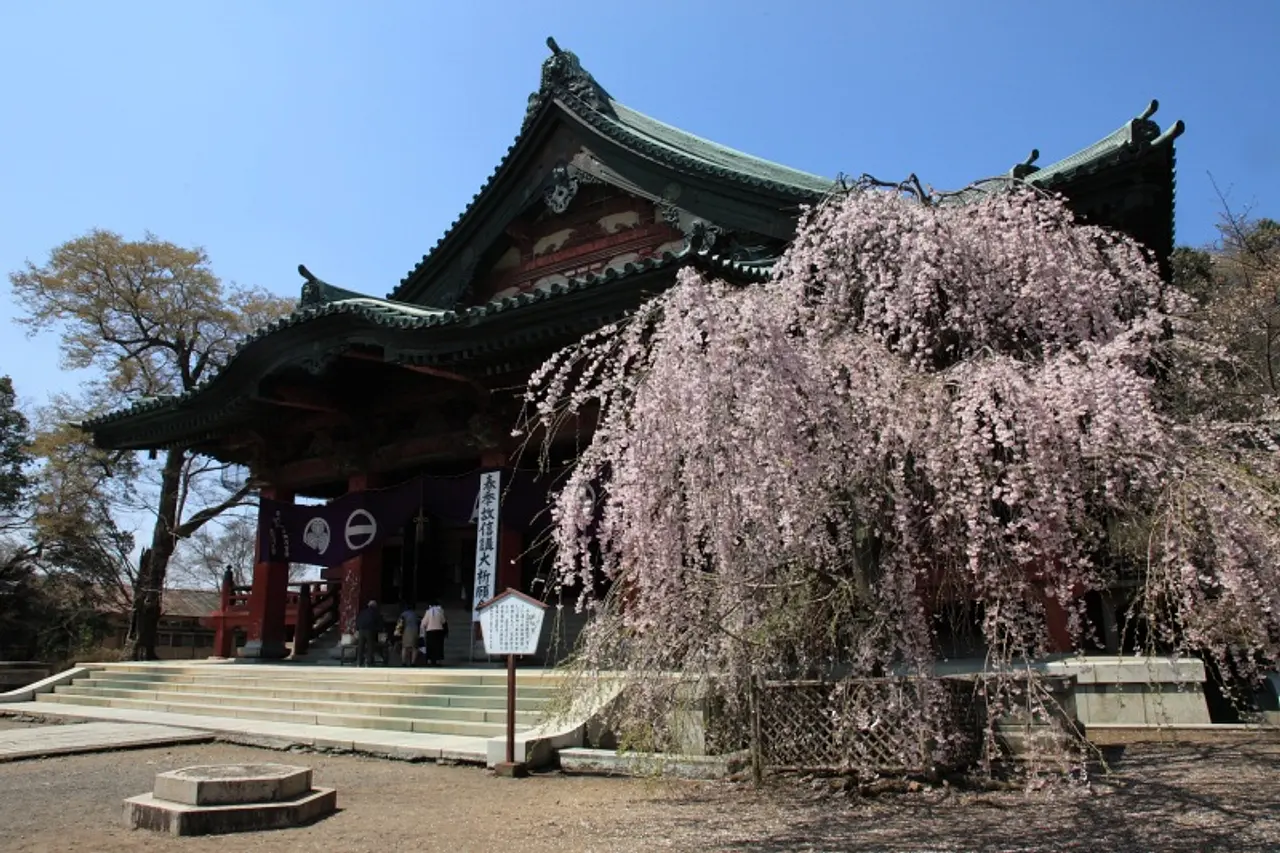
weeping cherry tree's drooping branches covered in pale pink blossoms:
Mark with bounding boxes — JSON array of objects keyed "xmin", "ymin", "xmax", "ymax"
[{"xmin": 517, "ymin": 181, "xmax": 1280, "ymax": 778}]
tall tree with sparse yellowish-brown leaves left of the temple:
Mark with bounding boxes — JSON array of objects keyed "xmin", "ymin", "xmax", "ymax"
[{"xmin": 9, "ymin": 231, "xmax": 293, "ymax": 660}]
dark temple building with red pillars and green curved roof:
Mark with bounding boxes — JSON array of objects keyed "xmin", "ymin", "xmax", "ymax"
[{"xmin": 84, "ymin": 40, "xmax": 1183, "ymax": 657}]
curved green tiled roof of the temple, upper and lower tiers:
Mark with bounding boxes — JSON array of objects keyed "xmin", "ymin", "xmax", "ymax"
[{"xmin": 82, "ymin": 38, "xmax": 1184, "ymax": 446}]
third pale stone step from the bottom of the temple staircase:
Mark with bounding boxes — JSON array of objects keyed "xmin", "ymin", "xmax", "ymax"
[{"xmin": 74, "ymin": 675, "xmax": 548, "ymax": 711}]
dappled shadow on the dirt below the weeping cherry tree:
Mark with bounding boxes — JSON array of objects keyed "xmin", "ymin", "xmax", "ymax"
[{"xmin": 632, "ymin": 744, "xmax": 1280, "ymax": 853}]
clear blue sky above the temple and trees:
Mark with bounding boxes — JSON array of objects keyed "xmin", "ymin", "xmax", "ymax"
[{"xmin": 0, "ymin": 0, "xmax": 1280, "ymax": 402}]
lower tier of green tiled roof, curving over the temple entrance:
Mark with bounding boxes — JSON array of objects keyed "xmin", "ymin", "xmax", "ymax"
[{"xmin": 81, "ymin": 244, "xmax": 771, "ymax": 430}]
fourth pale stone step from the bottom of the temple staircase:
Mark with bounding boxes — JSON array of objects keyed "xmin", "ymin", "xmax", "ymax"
[{"xmin": 80, "ymin": 671, "xmax": 559, "ymax": 702}]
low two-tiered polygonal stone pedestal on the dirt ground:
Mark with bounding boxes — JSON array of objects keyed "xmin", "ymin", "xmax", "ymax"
[{"xmin": 124, "ymin": 765, "xmax": 338, "ymax": 835}]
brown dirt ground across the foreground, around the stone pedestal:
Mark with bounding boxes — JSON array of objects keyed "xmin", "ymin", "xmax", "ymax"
[{"xmin": 0, "ymin": 744, "xmax": 1280, "ymax": 853}]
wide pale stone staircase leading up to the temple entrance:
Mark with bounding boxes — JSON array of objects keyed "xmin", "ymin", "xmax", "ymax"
[{"xmin": 36, "ymin": 663, "xmax": 558, "ymax": 738}]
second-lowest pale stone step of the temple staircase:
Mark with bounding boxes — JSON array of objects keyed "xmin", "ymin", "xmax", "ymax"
[{"xmin": 54, "ymin": 683, "xmax": 540, "ymax": 726}]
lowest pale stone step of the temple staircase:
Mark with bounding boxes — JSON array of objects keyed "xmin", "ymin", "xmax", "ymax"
[{"xmin": 36, "ymin": 693, "xmax": 526, "ymax": 738}]
